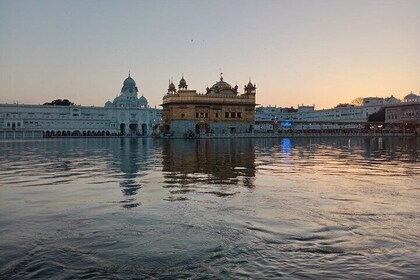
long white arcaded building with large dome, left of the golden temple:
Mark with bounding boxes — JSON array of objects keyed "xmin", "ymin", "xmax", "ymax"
[{"xmin": 0, "ymin": 75, "xmax": 162, "ymax": 138}]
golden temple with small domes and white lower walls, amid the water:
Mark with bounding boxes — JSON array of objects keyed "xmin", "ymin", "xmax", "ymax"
[{"xmin": 162, "ymin": 76, "xmax": 256, "ymax": 135}]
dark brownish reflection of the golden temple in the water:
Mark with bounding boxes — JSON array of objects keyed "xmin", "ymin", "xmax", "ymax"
[{"xmin": 162, "ymin": 139, "xmax": 255, "ymax": 187}]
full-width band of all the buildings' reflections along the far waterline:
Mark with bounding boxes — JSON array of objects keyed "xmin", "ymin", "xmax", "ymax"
[{"xmin": 0, "ymin": 137, "xmax": 420, "ymax": 202}]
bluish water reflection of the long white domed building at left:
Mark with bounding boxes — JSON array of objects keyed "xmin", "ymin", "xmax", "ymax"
[{"xmin": 0, "ymin": 138, "xmax": 160, "ymax": 208}]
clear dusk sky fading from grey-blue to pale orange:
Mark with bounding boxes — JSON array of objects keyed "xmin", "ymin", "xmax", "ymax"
[{"xmin": 0, "ymin": 0, "xmax": 420, "ymax": 109}]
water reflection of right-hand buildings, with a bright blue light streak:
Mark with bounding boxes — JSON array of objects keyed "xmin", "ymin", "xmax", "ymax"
[{"xmin": 255, "ymin": 137, "xmax": 420, "ymax": 177}]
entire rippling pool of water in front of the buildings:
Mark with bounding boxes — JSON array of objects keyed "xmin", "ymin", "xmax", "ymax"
[{"xmin": 0, "ymin": 138, "xmax": 420, "ymax": 279}]
